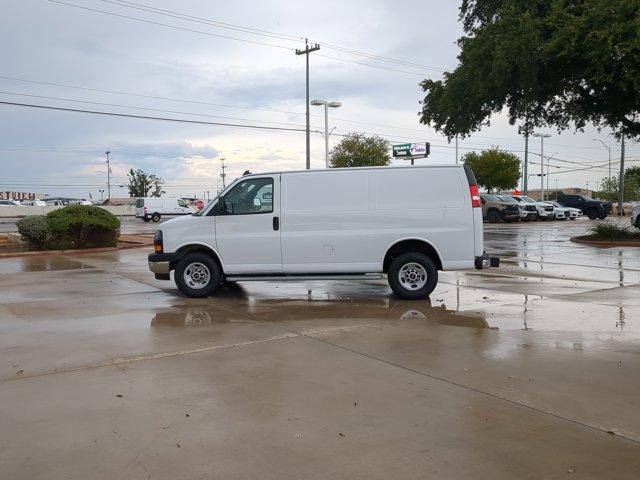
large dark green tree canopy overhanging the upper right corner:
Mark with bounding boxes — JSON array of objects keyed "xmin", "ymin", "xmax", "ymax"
[{"xmin": 420, "ymin": 0, "xmax": 640, "ymax": 138}]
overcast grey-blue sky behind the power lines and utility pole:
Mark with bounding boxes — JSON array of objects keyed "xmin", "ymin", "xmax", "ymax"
[{"xmin": 0, "ymin": 0, "xmax": 640, "ymax": 199}]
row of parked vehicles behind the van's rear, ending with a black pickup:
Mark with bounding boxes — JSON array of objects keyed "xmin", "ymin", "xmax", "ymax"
[{"xmin": 480, "ymin": 193, "xmax": 612, "ymax": 223}]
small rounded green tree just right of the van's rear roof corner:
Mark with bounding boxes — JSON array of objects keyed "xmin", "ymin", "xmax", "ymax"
[{"xmin": 462, "ymin": 148, "xmax": 520, "ymax": 193}]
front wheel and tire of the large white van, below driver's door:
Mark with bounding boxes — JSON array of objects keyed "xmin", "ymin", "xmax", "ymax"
[{"xmin": 174, "ymin": 252, "xmax": 222, "ymax": 298}]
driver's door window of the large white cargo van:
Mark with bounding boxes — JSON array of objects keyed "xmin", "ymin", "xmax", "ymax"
[{"xmin": 224, "ymin": 178, "xmax": 273, "ymax": 215}]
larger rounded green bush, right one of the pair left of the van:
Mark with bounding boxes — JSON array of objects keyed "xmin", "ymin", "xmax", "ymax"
[{"xmin": 46, "ymin": 205, "xmax": 120, "ymax": 249}]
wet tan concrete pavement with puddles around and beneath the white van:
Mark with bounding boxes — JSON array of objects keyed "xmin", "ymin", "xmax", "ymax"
[{"xmin": 0, "ymin": 217, "xmax": 640, "ymax": 479}]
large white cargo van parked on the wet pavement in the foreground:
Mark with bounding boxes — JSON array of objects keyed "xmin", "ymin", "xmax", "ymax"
[{"xmin": 149, "ymin": 165, "xmax": 499, "ymax": 299}]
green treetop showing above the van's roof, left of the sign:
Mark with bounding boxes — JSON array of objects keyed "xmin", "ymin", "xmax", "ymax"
[{"xmin": 329, "ymin": 133, "xmax": 391, "ymax": 168}]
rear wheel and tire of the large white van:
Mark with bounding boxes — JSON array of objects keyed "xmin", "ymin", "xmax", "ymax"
[{"xmin": 387, "ymin": 252, "xmax": 438, "ymax": 300}]
